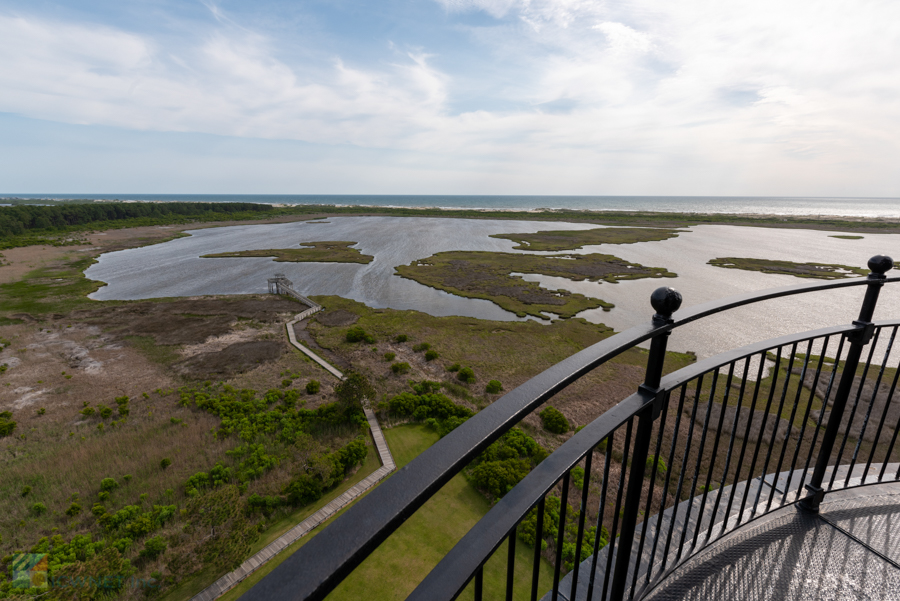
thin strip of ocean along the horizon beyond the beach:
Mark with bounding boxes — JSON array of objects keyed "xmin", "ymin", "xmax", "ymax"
[{"xmin": 0, "ymin": 193, "xmax": 900, "ymax": 218}]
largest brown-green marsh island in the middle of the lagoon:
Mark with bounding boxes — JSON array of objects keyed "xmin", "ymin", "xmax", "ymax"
[{"xmin": 395, "ymin": 251, "xmax": 675, "ymax": 319}]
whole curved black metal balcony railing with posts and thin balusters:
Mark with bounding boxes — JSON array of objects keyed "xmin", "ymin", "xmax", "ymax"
[{"xmin": 244, "ymin": 256, "xmax": 900, "ymax": 601}]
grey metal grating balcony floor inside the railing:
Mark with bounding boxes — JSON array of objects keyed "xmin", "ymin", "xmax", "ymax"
[{"xmin": 646, "ymin": 485, "xmax": 900, "ymax": 601}]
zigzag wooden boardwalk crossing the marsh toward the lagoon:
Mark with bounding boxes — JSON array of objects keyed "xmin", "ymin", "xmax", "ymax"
[{"xmin": 191, "ymin": 305, "xmax": 397, "ymax": 601}]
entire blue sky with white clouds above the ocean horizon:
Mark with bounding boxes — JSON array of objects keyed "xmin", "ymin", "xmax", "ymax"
[{"xmin": 0, "ymin": 0, "xmax": 900, "ymax": 197}]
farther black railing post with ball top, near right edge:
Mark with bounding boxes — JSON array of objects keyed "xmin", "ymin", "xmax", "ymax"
[{"xmin": 799, "ymin": 255, "xmax": 894, "ymax": 513}]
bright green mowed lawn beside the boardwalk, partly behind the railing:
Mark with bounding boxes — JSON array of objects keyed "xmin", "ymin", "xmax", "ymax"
[{"xmin": 328, "ymin": 425, "xmax": 553, "ymax": 601}]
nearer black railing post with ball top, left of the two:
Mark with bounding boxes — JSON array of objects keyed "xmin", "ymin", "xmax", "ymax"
[{"xmin": 610, "ymin": 287, "xmax": 682, "ymax": 601}]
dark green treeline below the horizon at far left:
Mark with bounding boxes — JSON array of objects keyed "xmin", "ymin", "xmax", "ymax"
[{"xmin": 0, "ymin": 202, "xmax": 274, "ymax": 239}]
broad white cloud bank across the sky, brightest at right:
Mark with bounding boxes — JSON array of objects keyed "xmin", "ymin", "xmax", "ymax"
[{"xmin": 0, "ymin": 0, "xmax": 900, "ymax": 194}]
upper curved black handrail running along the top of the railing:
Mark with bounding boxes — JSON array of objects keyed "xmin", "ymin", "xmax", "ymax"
[{"xmin": 243, "ymin": 257, "xmax": 900, "ymax": 601}]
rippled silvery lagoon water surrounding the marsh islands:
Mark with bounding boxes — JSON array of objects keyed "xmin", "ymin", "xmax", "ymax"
[{"xmin": 86, "ymin": 217, "xmax": 900, "ymax": 357}]
